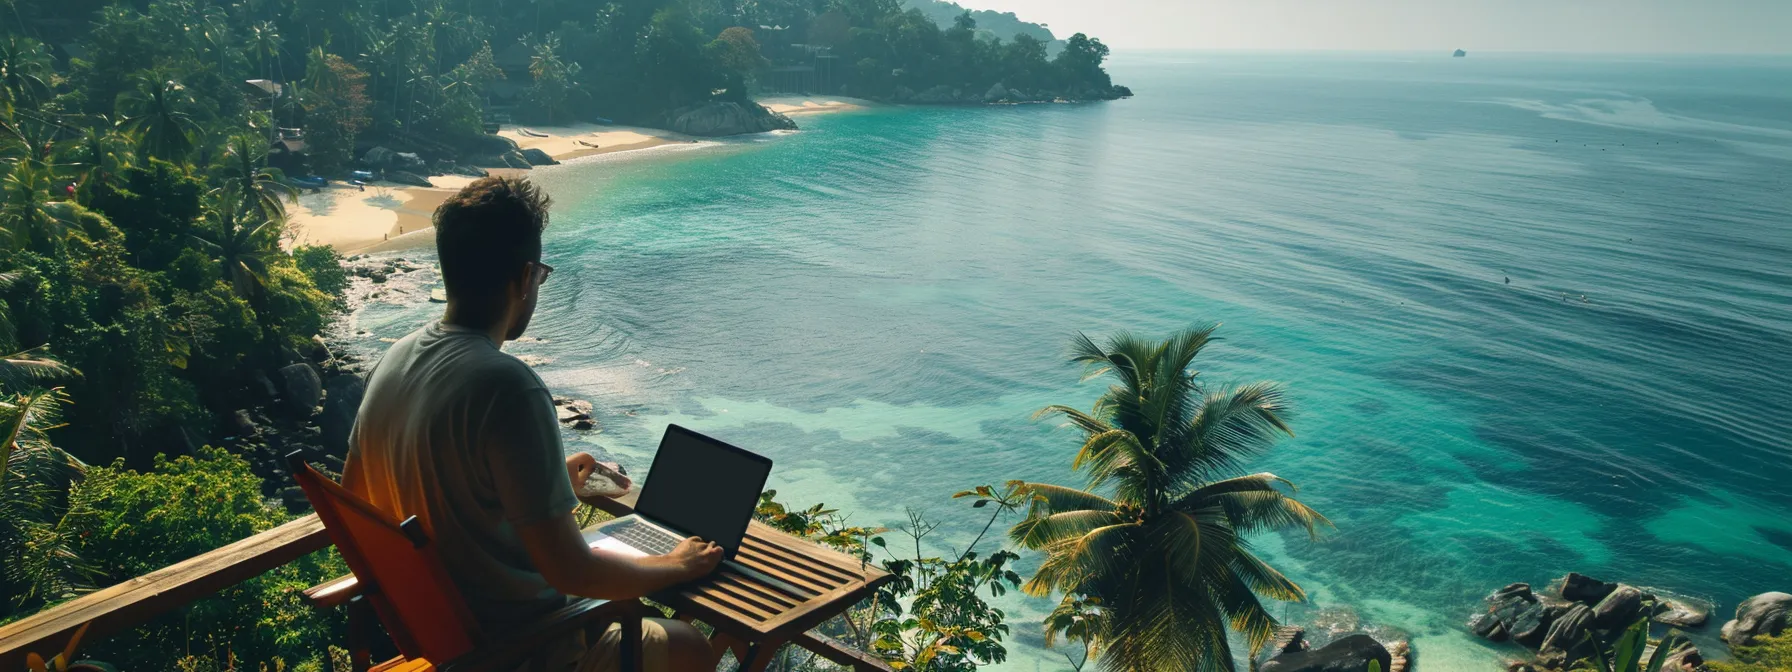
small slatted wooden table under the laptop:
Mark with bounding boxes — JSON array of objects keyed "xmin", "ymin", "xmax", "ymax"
[{"xmin": 593, "ymin": 493, "xmax": 892, "ymax": 672}]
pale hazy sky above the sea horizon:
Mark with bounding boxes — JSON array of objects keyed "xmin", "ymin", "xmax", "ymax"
[{"xmin": 959, "ymin": 0, "xmax": 1792, "ymax": 54}]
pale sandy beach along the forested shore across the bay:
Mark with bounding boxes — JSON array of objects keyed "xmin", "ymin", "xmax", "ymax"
[{"xmin": 287, "ymin": 97, "xmax": 864, "ymax": 254}]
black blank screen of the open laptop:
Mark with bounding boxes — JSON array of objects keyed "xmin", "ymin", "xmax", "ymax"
[{"xmin": 634, "ymin": 425, "xmax": 772, "ymax": 557}]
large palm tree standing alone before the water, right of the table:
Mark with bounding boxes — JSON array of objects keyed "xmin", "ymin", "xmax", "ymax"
[{"xmin": 1009, "ymin": 324, "xmax": 1331, "ymax": 672}]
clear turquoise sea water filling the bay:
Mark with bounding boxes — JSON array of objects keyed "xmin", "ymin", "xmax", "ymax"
[{"xmin": 338, "ymin": 54, "xmax": 1792, "ymax": 670}]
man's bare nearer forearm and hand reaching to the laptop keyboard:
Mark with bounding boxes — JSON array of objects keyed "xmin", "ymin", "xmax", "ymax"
[{"xmin": 516, "ymin": 511, "xmax": 722, "ymax": 600}]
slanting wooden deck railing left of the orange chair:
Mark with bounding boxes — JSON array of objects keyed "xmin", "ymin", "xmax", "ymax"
[{"xmin": 0, "ymin": 514, "xmax": 330, "ymax": 672}]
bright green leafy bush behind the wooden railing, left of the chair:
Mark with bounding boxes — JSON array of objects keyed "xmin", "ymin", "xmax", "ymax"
[{"xmin": 68, "ymin": 448, "xmax": 348, "ymax": 670}]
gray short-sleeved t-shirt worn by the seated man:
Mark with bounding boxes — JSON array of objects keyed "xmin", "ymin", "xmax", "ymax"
[{"xmin": 342, "ymin": 323, "xmax": 579, "ymax": 629}]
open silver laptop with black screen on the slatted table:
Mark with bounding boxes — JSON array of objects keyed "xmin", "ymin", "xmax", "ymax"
[{"xmin": 584, "ymin": 425, "xmax": 781, "ymax": 588}]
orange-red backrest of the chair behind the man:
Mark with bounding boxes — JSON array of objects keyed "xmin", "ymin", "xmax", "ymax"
[{"xmin": 287, "ymin": 452, "xmax": 480, "ymax": 663}]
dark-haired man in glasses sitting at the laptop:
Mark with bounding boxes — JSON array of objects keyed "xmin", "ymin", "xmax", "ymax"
[{"xmin": 342, "ymin": 177, "xmax": 722, "ymax": 672}]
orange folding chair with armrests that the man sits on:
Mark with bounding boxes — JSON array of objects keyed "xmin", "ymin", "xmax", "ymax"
[{"xmin": 287, "ymin": 452, "xmax": 643, "ymax": 672}]
